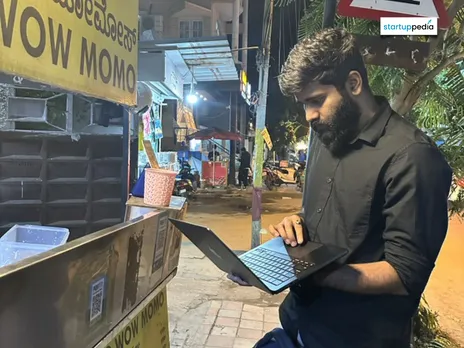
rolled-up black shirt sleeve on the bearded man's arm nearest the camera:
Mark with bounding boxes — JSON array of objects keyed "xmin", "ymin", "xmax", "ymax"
[{"xmin": 383, "ymin": 143, "xmax": 452, "ymax": 297}]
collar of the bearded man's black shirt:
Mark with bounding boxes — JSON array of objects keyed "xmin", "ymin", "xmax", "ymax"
[{"xmin": 353, "ymin": 96, "xmax": 393, "ymax": 146}]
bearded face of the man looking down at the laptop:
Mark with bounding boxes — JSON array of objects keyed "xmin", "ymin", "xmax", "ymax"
[{"xmin": 296, "ymin": 82, "xmax": 361, "ymax": 154}]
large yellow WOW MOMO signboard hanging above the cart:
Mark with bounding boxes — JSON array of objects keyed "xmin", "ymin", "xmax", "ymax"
[{"xmin": 0, "ymin": 0, "xmax": 139, "ymax": 105}]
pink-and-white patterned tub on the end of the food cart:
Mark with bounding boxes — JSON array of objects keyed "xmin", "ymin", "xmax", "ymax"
[{"xmin": 143, "ymin": 168, "xmax": 177, "ymax": 207}]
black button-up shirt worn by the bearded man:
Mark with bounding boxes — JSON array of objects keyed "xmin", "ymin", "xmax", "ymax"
[{"xmin": 281, "ymin": 98, "xmax": 452, "ymax": 348}]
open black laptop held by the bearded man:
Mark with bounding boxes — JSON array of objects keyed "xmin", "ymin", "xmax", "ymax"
[{"xmin": 169, "ymin": 219, "xmax": 348, "ymax": 294}]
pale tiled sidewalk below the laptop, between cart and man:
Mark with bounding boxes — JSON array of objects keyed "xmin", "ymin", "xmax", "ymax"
[{"xmin": 168, "ymin": 243, "xmax": 285, "ymax": 348}]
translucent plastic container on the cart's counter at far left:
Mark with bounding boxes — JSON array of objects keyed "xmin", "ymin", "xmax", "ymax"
[{"xmin": 0, "ymin": 225, "xmax": 69, "ymax": 267}]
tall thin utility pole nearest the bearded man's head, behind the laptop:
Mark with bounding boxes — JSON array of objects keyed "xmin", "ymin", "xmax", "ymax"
[{"xmin": 251, "ymin": 0, "xmax": 274, "ymax": 248}]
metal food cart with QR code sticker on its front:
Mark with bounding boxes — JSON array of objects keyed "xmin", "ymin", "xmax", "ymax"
[{"xmin": 0, "ymin": 196, "xmax": 186, "ymax": 348}]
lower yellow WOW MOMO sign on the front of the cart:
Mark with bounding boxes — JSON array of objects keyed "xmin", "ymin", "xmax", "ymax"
[{"xmin": 102, "ymin": 288, "xmax": 169, "ymax": 348}]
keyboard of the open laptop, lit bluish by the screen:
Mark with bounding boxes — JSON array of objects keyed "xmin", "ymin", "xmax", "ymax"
[{"xmin": 240, "ymin": 248, "xmax": 314, "ymax": 286}]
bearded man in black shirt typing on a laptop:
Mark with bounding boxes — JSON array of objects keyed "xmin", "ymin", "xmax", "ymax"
[{"xmin": 230, "ymin": 29, "xmax": 452, "ymax": 348}]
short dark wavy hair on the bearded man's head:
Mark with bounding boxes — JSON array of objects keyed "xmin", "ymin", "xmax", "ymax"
[{"xmin": 279, "ymin": 29, "xmax": 368, "ymax": 96}]
